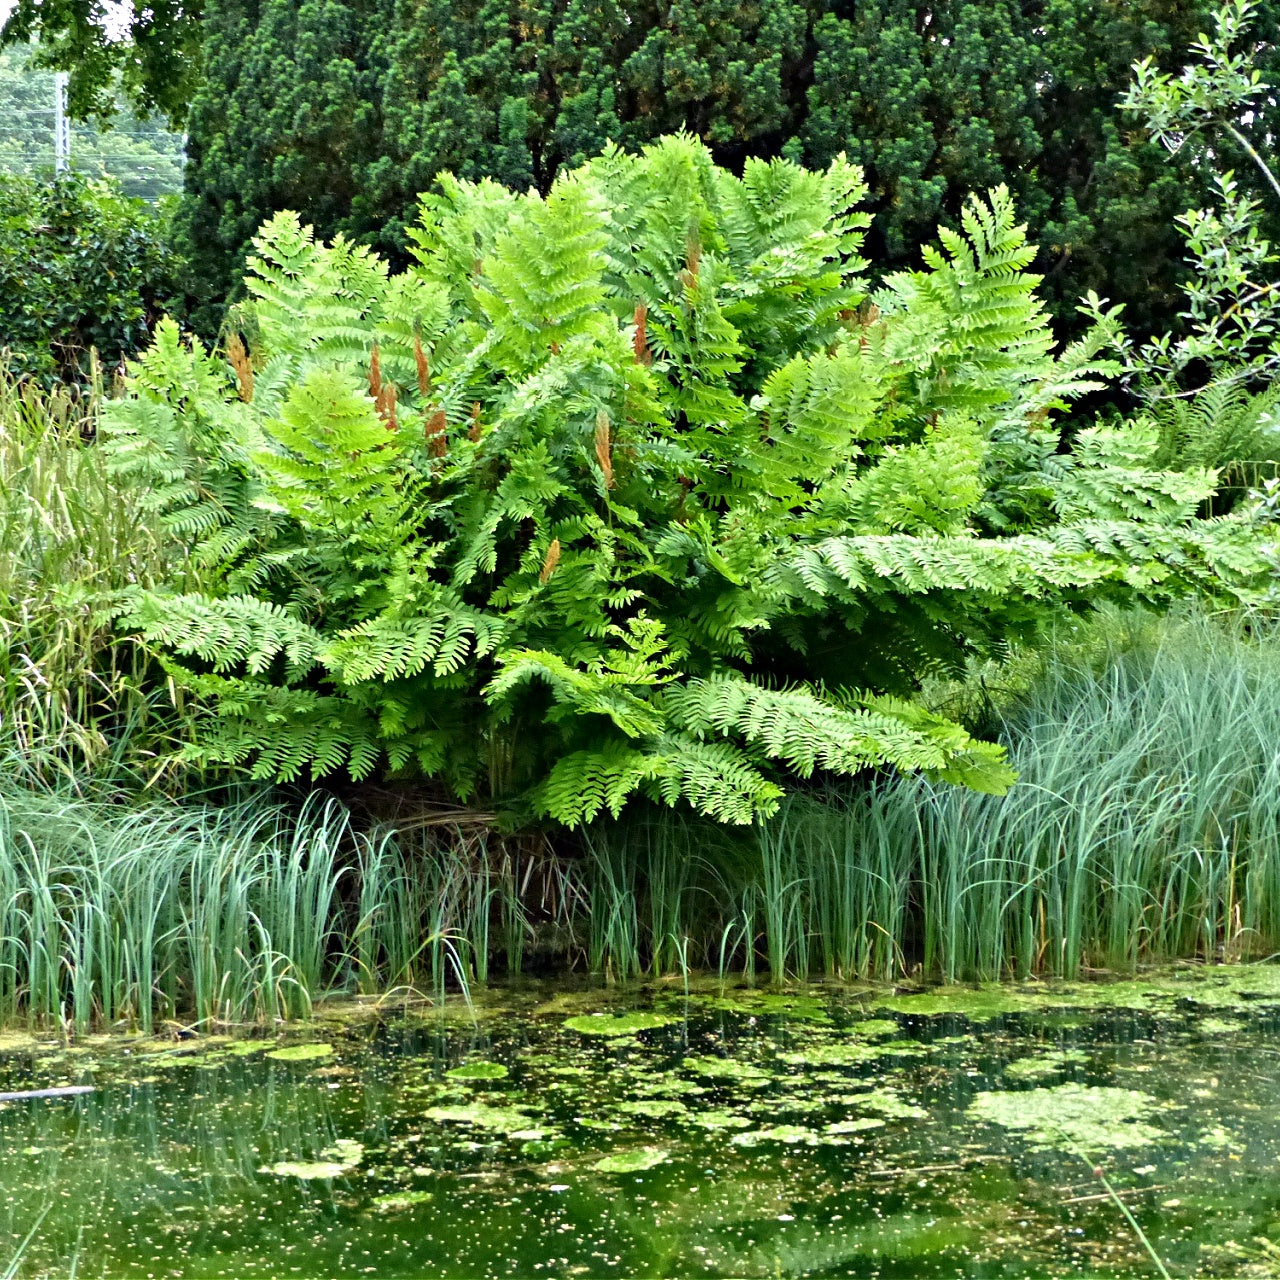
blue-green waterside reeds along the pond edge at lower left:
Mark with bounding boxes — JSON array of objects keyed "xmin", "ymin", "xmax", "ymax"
[{"xmin": 0, "ymin": 760, "xmax": 586, "ymax": 1032}]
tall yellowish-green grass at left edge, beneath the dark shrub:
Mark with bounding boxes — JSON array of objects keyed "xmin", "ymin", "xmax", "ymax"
[{"xmin": 0, "ymin": 370, "xmax": 189, "ymax": 781}]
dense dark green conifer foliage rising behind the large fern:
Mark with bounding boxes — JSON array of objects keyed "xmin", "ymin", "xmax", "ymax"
[{"xmin": 170, "ymin": 0, "xmax": 1276, "ymax": 335}]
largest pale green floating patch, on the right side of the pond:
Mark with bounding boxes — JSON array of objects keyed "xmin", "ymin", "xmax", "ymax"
[{"xmin": 969, "ymin": 1084, "xmax": 1166, "ymax": 1152}]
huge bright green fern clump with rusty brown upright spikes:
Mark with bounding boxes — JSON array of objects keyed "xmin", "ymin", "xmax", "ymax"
[{"xmin": 105, "ymin": 137, "xmax": 1266, "ymax": 826}]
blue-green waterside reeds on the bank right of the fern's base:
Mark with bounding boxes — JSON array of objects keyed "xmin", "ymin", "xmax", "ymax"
[{"xmin": 586, "ymin": 614, "xmax": 1280, "ymax": 980}]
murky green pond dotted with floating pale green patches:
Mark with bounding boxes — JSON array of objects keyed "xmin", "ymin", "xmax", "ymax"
[{"xmin": 0, "ymin": 966, "xmax": 1280, "ymax": 1277}]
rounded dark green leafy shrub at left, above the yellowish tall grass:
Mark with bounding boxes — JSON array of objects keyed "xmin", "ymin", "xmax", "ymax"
[{"xmin": 0, "ymin": 173, "xmax": 177, "ymax": 380}]
